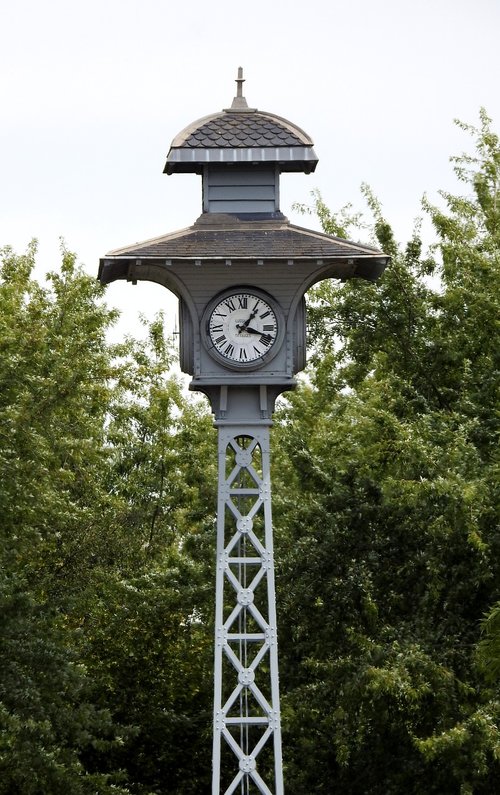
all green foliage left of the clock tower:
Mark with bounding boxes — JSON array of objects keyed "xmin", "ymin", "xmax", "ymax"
[{"xmin": 0, "ymin": 244, "xmax": 215, "ymax": 795}]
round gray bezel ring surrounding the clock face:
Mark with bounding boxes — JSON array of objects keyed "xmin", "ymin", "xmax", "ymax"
[{"xmin": 201, "ymin": 284, "xmax": 285, "ymax": 372}]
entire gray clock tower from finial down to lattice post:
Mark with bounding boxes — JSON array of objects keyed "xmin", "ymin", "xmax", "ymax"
[{"xmin": 99, "ymin": 69, "xmax": 388, "ymax": 795}]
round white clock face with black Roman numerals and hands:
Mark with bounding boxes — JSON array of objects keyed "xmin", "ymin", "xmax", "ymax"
[{"xmin": 206, "ymin": 290, "xmax": 282, "ymax": 368}]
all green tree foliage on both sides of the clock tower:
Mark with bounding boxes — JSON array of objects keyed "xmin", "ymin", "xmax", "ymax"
[{"xmin": 0, "ymin": 111, "xmax": 500, "ymax": 795}]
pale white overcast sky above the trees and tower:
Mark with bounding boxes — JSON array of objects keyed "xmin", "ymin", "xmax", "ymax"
[{"xmin": 0, "ymin": 0, "xmax": 500, "ymax": 338}]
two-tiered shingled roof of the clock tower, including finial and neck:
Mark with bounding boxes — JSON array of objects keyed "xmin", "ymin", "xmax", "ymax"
[{"xmin": 98, "ymin": 68, "xmax": 388, "ymax": 284}]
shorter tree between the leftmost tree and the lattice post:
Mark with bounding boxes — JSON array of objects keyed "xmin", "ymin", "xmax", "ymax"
[{"xmin": 78, "ymin": 318, "xmax": 216, "ymax": 795}]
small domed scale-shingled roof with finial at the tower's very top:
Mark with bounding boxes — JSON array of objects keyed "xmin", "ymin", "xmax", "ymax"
[{"xmin": 164, "ymin": 69, "xmax": 318, "ymax": 174}]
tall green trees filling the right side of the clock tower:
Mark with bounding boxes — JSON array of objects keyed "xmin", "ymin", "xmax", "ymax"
[{"xmin": 275, "ymin": 112, "xmax": 500, "ymax": 795}]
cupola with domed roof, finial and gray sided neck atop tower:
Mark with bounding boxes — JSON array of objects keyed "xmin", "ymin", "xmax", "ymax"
[{"xmin": 164, "ymin": 67, "xmax": 318, "ymax": 220}]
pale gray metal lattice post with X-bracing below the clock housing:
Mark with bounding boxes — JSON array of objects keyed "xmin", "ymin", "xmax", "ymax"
[{"xmin": 212, "ymin": 424, "xmax": 283, "ymax": 795}]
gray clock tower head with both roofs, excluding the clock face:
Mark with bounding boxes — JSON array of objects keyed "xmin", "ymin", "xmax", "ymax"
[{"xmin": 98, "ymin": 65, "xmax": 388, "ymax": 382}]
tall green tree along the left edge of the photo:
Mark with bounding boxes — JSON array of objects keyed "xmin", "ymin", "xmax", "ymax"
[{"xmin": 0, "ymin": 244, "xmax": 131, "ymax": 795}]
